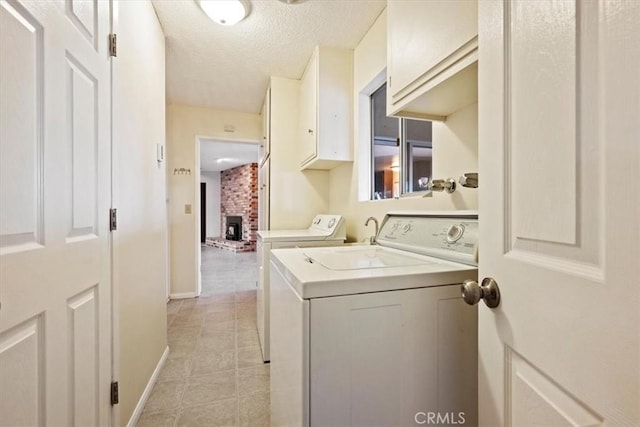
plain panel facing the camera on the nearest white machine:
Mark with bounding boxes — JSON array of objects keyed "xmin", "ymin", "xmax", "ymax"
[{"xmin": 308, "ymin": 285, "xmax": 477, "ymax": 426}]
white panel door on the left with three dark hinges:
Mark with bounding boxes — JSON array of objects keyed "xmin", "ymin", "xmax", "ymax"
[{"xmin": 0, "ymin": 0, "xmax": 112, "ymax": 426}]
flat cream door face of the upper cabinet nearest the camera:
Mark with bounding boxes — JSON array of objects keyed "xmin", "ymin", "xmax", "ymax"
[{"xmin": 387, "ymin": 0, "xmax": 478, "ymax": 97}]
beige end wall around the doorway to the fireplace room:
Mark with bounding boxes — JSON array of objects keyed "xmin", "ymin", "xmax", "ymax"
[{"xmin": 167, "ymin": 104, "xmax": 262, "ymax": 298}]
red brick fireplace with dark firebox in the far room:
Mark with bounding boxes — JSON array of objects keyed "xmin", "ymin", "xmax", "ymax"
[{"xmin": 207, "ymin": 163, "xmax": 258, "ymax": 252}]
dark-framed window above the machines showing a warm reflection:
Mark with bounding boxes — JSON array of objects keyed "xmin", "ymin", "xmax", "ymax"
[{"xmin": 371, "ymin": 83, "xmax": 432, "ymax": 199}]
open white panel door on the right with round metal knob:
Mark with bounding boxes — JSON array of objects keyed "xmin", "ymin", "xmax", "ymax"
[{"xmin": 478, "ymin": 0, "xmax": 640, "ymax": 426}]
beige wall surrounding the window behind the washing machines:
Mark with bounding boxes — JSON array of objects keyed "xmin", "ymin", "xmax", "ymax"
[{"xmin": 329, "ymin": 11, "xmax": 478, "ymax": 241}]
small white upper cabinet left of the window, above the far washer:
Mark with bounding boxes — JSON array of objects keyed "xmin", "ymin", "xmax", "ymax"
[{"xmin": 298, "ymin": 46, "xmax": 353, "ymax": 169}]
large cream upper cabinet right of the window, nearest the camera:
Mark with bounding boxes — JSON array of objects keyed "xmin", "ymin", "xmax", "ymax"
[{"xmin": 387, "ymin": 0, "xmax": 478, "ymax": 120}]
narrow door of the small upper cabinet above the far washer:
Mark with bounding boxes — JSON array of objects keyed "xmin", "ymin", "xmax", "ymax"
[{"xmin": 298, "ymin": 50, "xmax": 318, "ymax": 164}]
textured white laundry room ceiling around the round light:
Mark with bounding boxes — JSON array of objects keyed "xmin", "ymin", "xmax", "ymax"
[{"xmin": 152, "ymin": 0, "xmax": 386, "ymax": 113}]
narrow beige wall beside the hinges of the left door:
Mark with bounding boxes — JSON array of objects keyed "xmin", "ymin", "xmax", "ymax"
[{"xmin": 113, "ymin": 1, "xmax": 168, "ymax": 425}]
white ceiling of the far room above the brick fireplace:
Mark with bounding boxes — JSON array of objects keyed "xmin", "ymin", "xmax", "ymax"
[{"xmin": 200, "ymin": 139, "xmax": 258, "ymax": 172}]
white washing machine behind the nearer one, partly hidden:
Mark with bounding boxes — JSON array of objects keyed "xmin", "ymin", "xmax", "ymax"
[{"xmin": 256, "ymin": 215, "xmax": 347, "ymax": 362}]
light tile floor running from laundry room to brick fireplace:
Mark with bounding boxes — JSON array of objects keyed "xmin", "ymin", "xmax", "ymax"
[{"xmin": 137, "ymin": 246, "xmax": 270, "ymax": 427}]
